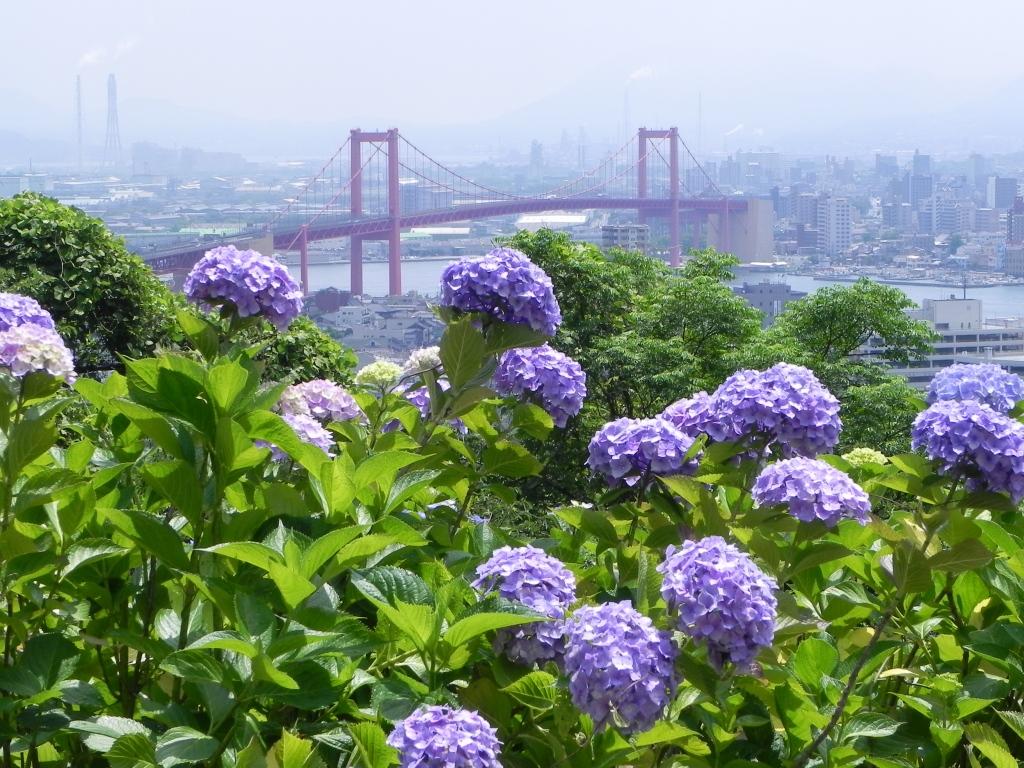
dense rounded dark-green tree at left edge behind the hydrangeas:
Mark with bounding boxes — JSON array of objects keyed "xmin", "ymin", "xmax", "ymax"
[{"xmin": 0, "ymin": 193, "xmax": 172, "ymax": 371}]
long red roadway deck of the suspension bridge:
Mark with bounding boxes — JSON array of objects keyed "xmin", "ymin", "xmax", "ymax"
[{"xmin": 139, "ymin": 197, "xmax": 746, "ymax": 271}]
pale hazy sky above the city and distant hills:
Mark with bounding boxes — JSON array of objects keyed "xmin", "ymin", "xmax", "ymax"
[{"xmin": 6, "ymin": 0, "xmax": 1024, "ymax": 155}]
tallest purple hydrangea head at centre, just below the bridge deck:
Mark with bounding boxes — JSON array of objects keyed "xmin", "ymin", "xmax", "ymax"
[{"xmin": 441, "ymin": 248, "xmax": 562, "ymax": 336}]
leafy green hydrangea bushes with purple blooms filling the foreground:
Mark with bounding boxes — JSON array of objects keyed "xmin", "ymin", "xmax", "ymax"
[{"xmin": 0, "ymin": 241, "xmax": 1024, "ymax": 768}]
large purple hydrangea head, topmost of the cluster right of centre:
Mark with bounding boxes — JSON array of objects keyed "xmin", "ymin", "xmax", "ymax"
[{"xmin": 705, "ymin": 362, "xmax": 843, "ymax": 457}]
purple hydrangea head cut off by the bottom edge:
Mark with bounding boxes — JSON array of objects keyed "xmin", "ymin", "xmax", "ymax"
[{"xmin": 387, "ymin": 706, "xmax": 502, "ymax": 768}]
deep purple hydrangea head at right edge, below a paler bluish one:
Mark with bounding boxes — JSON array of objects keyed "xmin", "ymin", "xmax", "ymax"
[{"xmin": 910, "ymin": 400, "xmax": 1024, "ymax": 502}]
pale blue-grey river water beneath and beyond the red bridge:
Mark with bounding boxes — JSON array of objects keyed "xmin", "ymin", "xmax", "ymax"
[{"xmin": 303, "ymin": 259, "xmax": 1024, "ymax": 317}]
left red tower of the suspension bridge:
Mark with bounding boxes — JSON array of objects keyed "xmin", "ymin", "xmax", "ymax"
[{"xmin": 349, "ymin": 128, "xmax": 401, "ymax": 296}]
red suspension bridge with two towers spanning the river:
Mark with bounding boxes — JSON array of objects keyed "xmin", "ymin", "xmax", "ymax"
[{"xmin": 143, "ymin": 128, "xmax": 748, "ymax": 295}]
